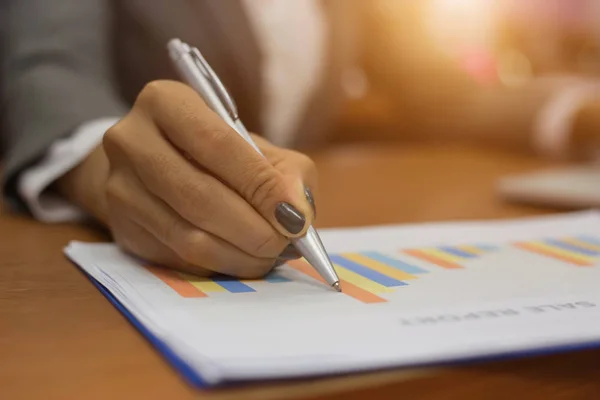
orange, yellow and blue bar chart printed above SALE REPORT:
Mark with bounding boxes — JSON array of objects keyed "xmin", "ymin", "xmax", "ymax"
[{"xmin": 146, "ymin": 236, "xmax": 600, "ymax": 304}]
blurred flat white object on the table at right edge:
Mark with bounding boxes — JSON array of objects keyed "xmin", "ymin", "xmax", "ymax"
[{"xmin": 498, "ymin": 165, "xmax": 600, "ymax": 209}]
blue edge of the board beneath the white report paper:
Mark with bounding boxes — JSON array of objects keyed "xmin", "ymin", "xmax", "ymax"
[{"xmin": 68, "ymin": 263, "xmax": 600, "ymax": 389}]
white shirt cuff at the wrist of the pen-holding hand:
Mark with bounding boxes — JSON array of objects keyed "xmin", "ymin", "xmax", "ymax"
[{"xmin": 17, "ymin": 117, "xmax": 119, "ymax": 223}]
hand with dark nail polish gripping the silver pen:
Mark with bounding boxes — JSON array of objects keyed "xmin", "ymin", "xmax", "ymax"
[{"xmin": 58, "ymin": 81, "xmax": 316, "ymax": 278}]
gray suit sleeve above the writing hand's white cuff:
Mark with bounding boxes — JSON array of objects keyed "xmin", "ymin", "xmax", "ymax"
[{"xmin": 0, "ymin": 0, "xmax": 127, "ymax": 211}]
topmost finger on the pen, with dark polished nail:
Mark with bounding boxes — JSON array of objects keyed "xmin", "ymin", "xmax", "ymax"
[{"xmin": 138, "ymin": 81, "xmax": 312, "ymax": 237}]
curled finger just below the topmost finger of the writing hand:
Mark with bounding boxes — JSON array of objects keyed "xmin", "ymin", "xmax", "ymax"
[{"xmin": 104, "ymin": 111, "xmax": 288, "ymax": 258}]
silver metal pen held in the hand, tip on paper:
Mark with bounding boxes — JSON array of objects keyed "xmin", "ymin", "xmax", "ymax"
[{"xmin": 167, "ymin": 39, "xmax": 342, "ymax": 292}]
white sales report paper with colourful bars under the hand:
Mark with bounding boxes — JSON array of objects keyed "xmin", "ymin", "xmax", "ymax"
[{"xmin": 65, "ymin": 212, "xmax": 600, "ymax": 386}]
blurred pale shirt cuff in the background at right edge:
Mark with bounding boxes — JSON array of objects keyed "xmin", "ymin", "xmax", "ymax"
[{"xmin": 533, "ymin": 81, "xmax": 600, "ymax": 158}]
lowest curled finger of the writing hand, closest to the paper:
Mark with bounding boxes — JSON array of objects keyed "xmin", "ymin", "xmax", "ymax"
[{"xmin": 107, "ymin": 171, "xmax": 275, "ymax": 278}]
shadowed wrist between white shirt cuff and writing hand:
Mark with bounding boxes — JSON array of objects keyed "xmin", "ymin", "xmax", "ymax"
[{"xmin": 53, "ymin": 145, "xmax": 109, "ymax": 225}]
